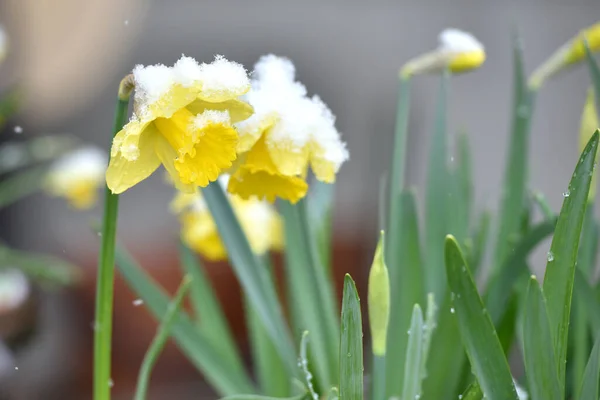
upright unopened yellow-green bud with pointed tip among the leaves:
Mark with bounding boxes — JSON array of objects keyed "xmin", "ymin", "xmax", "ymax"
[{"xmin": 368, "ymin": 231, "xmax": 390, "ymax": 356}]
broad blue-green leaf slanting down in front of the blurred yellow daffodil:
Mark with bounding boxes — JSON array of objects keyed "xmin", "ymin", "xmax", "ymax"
[{"xmin": 202, "ymin": 182, "xmax": 298, "ymax": 376}]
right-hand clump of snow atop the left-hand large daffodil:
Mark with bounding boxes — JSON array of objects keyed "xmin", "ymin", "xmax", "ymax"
[{"xmin": 200, "ymin": 55, "xmax": 250, "ymax": 101}]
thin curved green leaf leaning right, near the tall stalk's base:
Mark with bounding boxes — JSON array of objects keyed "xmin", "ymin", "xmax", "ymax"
[{"xmin": 135, "ymin": 275, "xmax": 192, "ymax": 400}]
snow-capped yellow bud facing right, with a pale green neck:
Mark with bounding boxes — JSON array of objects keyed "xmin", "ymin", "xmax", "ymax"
[{"xmin": 401, "ymin": 29, "xmax": 485, "ymax": 76}]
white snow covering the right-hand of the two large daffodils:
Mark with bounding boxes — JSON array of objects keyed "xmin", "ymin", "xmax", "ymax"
[{"xmin": 236, "ymin": 54, "xmax": 349, "ymax": 170}]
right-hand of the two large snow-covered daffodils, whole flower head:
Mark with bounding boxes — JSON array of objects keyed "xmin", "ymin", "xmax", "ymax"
[{"xmin": 228, "ymin": 55, "xmax": 349, "ymax": 203}]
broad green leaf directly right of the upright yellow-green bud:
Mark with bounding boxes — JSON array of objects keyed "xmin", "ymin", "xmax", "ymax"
[{"xmin": 385, "ymin": 190, "xmax": 424, "ymax": 398}]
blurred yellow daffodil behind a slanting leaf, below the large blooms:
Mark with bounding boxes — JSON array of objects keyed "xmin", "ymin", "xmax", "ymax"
[{"xmin": 171, "ymin": 177, "xmax": 283, "ymax": 261}]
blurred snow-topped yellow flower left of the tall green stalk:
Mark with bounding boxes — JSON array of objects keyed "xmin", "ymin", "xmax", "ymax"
[{"xmin": 44, "ymin": 147, "xmax": 108, "ymax": 209}]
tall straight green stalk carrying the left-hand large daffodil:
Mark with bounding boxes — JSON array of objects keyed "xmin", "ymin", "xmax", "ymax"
[{"xmin": 94, "ymin": 75, "xmax": 133, "ymax": 400}]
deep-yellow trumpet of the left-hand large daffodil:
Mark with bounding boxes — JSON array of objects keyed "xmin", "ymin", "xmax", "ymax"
[{"xmin": 175, "ymin": 123, "xmax": 238, "ymax": 187}]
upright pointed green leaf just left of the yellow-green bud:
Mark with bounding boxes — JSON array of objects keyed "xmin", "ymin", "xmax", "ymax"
[{"xmin": 340, "ymin": 274, "xmax": 363, "ymax": 400}]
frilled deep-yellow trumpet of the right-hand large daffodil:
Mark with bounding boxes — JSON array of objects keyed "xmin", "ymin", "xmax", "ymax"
[{"xmin": 227, "ymin": 165, "xmax": 308, "ymax": 203}]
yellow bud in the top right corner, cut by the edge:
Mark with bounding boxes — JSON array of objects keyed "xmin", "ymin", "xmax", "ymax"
[{"xmin": 529, "ymin": 22, "xmax": 600, "ymax": 89}]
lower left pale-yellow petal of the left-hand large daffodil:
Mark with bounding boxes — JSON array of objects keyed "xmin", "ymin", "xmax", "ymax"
[{"xmin": 106, "ymin": 124, "xmax": 160, "ymax": 194}]
